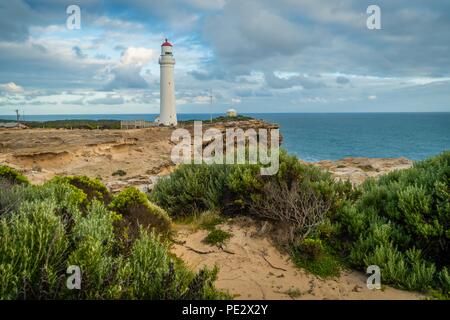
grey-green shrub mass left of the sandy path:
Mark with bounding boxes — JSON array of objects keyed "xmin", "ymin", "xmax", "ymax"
[{"xmin": 0, "ymin": 166, "xmax": 227, "ymax": 299}]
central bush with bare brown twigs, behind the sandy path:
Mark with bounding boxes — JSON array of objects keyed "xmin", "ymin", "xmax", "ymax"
[{"xmin": 150, "ymin": 151, "xmax": 354, "ymax": 276}]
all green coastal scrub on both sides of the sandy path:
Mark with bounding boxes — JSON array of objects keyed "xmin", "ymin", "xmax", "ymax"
[{"xmin": 0, "ymin": 152, "xmax": 450, "ymax": 299}]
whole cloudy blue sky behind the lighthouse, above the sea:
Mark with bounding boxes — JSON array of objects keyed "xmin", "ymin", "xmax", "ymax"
[{"xmin": 0, "ymin": 0, "xmax": 450, "ymax": 115}]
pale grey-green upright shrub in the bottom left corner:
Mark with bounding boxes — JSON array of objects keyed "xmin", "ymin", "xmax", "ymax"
[{"xmin": 0, "ymin": 199, "xmax": 69, "ymax": 299}]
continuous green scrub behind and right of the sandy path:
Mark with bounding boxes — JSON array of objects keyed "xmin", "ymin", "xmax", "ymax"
[{"xmin": 150, "ymin": 152, "xmax": 450, "ymax": 296}]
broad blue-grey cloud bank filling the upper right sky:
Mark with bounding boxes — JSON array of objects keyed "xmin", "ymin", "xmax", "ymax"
[{"xmin": 205, "ymin": 0, "xmax": 450, "ymax": 76}]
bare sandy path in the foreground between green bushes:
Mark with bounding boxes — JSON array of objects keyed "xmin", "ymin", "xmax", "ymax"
[{"xmin": 172, "ymin": 220, "xmax": 423, "ymax": 300}]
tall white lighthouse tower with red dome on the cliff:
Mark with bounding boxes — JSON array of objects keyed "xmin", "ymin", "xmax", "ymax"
[{"xmin": 159, "ymin": 39, "xmax": 177, "ymax": 126}]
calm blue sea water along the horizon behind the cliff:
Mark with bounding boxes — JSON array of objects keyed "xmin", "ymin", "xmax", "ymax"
[{"xmin": 0, "ymin": 113, "xmax": 450, "ymax": 161}]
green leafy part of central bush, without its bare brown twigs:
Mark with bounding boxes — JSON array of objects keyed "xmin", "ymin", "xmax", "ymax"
[{"xmin": 150, "ymin": 151, "xmax": 351, "ymax": 220}]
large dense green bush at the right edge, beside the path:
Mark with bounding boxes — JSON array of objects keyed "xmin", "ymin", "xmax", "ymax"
[{"xmin": 331, "ymin": 152, "xmax": 450, "ymax": 294}]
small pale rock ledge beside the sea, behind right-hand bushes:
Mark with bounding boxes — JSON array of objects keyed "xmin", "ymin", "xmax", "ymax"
[{"xmin": 314, "ymin": 158, "xmax": 413, "ymax": 185}]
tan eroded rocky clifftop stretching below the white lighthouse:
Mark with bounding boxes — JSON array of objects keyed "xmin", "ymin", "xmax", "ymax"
[{"xmin": 0, "ymin": 120, "xmax": 278, "ymax": 192}]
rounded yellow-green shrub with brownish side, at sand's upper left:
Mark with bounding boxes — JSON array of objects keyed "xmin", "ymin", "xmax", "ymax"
[{"xmin": 109, "ymin": 187, "xmax": 171, "ymax": 235}]
